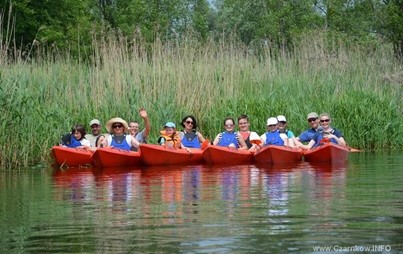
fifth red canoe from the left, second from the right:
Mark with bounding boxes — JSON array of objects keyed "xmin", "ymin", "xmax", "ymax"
[{"xmin": 255, "ymin": 146, "xmax": 302, "ymax": 164}]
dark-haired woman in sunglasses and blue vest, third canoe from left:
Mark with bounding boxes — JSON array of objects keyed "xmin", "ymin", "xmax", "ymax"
[{"xmin": 179, "ymin": 115, "xmax": 206, "ymax": 148}]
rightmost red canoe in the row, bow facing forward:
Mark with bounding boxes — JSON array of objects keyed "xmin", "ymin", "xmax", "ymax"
[{"xmin": 304, "ymin": 143, "xmax": 349, "ymax": 162}]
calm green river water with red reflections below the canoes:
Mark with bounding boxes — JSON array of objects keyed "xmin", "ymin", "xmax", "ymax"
[{"xmin": 0, "ymin": 153, "xmax": 403, "ymax": 253}]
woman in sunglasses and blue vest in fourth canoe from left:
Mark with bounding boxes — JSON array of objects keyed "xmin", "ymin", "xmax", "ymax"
[{"xmin": 213, "ymin": 117, "xmax": 248, "ymax": 150}]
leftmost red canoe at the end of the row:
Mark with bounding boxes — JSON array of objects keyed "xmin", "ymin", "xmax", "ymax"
[{"xmin": 52, "ymin": 146, "xmax": 93, "ymax": 167}]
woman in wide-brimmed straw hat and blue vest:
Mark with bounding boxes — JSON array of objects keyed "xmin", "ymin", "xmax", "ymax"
[{"xmin": 103, "ymin": 117, "xmax": 140, "ymax": 151}]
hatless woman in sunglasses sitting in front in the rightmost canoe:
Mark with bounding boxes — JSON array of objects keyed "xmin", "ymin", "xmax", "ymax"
[{"xmin": 299, "ymin": 113, "xmax": 346, "ymax": 149}]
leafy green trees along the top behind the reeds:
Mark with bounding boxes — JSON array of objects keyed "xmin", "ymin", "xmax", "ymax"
[{"xmin": 0, "ymin": 0, "xmax": 403, "ymax": 58}]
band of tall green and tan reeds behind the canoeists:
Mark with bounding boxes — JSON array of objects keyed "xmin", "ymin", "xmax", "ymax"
[{"xmin": 0, "ymin": 30, "xmax": 403, "ymax": 166}]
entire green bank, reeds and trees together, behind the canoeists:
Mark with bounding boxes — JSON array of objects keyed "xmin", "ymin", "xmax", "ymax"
[{"xmin": 0, "ymin": 0, "xmax": 403, "ymax": 167}]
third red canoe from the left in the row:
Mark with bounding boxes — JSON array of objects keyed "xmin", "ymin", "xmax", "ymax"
[{"xmin": 140, "ymin": 144, "xmax": 203, "ymax": 166}]
